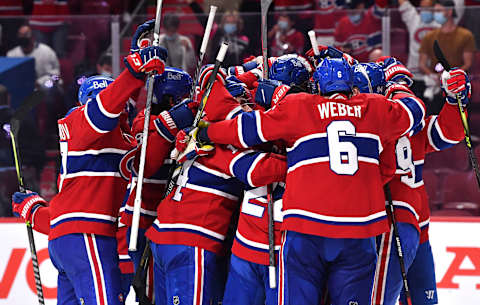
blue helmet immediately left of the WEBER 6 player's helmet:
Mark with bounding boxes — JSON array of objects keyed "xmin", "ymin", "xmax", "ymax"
[{"xmin": 268, "ymin": 54, "xmax": 312, "ymax": 87}]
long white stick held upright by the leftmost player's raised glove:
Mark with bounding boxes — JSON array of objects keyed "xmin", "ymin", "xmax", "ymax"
[{"xmin": 128, "ymin": 0, "xmax": 163, "ymax": 251}]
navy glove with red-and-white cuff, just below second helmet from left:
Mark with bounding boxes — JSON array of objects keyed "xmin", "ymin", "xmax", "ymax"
[{"xmin": 154, "ymin": 99, "xmax": 198, "ymax": 143}]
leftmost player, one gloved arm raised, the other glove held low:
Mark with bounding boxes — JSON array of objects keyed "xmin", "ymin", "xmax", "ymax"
[{"xmin": 13, "ymin": 42, "xmax": 167, "ymax": 305}]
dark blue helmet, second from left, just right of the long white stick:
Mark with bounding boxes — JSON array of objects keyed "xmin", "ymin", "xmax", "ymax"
[{"xmin": 153, "ymin": 67, "xmax": 193, "ymax": 102}]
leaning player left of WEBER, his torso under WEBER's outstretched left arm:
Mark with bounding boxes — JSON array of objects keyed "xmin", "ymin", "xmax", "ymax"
[{"xmin": 141, "ymin": 66, "xmax": 286, "ymax": 304}]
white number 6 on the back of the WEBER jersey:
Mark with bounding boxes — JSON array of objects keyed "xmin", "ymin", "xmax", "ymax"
[{"xmin": 327, "ymin": 121, "xmax": 358, "ymax": 175}]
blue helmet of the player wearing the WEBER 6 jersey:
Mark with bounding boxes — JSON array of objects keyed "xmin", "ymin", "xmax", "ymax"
[{"xmin": 313, "ymin": 58, "xmax": 353, "ymax": 95}]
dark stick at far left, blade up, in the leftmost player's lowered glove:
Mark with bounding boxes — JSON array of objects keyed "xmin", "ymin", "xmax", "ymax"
[{"xmin": 4, "ymin": 91, "xmax": 45, "ymax": 305}]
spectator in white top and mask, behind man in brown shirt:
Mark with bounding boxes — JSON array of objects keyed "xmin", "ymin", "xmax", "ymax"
[{"xmin": 398, "ymin": 0, "xmax": 440, "ymax": 99}]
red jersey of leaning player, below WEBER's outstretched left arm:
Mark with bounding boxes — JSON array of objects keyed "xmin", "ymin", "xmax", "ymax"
[{"xmin": 146, "ymin": 146, "xmax": 286, "ymax": 254}]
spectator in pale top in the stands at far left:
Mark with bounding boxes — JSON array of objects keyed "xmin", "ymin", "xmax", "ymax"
[{"xmin": 7, "ymin": 25, "xmax": 60, "ymax": 87}]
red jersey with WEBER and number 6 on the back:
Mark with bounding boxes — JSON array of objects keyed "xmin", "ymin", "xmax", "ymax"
[{"xmin": 208, "ymin": 93, "xmax": 425, "ymax": 238}]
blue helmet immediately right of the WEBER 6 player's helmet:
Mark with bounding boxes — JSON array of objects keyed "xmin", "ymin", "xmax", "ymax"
[{"xmin": 353, "ymin": 62, "xmax": 386, "ymax": 94}]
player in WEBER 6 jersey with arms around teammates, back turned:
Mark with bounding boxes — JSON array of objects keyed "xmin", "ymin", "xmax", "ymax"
[{"xmin": 183, "ymin": 59, "xmax": 425, "ymax": 304}]
